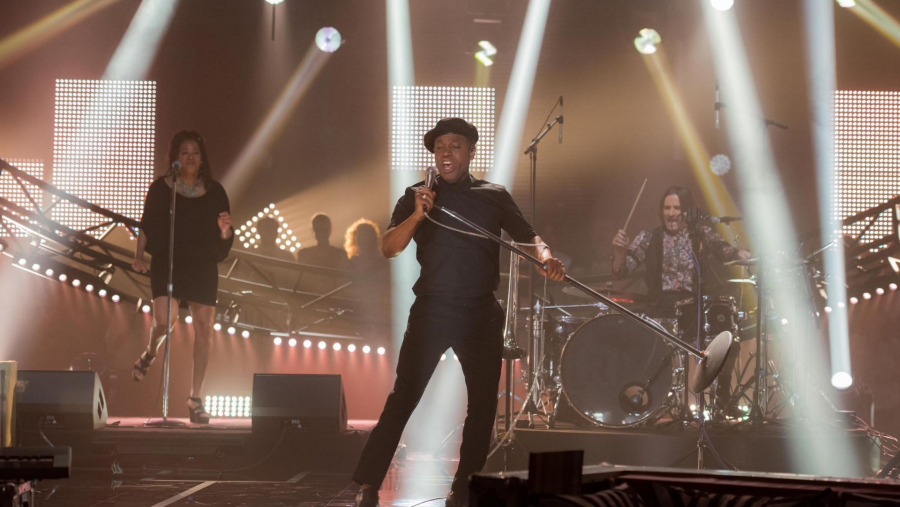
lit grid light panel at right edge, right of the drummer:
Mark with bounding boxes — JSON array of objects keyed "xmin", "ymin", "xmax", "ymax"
[{"xmin": 834, "ymin": 90, "xmax": 900, "ymax": 243}]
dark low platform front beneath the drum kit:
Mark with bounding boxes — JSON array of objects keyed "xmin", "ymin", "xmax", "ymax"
[{"xmin": 485, "ymin": 426, "xmax": 881, "ymax": 477}]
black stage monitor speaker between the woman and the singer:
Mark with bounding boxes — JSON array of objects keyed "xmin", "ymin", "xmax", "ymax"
[{"xmin": 251, "ymin": 373, "xmax": 347, "ymax": 433}]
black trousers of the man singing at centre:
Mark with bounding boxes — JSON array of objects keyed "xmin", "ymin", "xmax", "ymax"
[{"xmin": 353, "ymin": 295, "xmax": 504, "ymax": 496}]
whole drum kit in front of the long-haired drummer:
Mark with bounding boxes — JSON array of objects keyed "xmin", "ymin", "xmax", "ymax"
[{"xmin": 506, "ymin": 254, "xmax": 792, "ymax": 428}]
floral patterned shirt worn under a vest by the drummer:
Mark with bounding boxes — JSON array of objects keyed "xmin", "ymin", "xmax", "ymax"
[{"xmin": 616, "ymin": 224, "xmax": 738, "ymax": 292}]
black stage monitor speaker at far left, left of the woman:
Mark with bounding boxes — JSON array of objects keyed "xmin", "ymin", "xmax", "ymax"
[{"xmin": 16, "ymin": 370, "xmax": 109, "ymax": 431}]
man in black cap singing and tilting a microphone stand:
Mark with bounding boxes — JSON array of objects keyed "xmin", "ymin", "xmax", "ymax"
[{"xmin": 353, "ymin": 118, "xmax": 565, "ymax": 507}]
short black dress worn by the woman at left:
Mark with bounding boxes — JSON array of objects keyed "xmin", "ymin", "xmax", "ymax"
[{"xmin": 141, "ymin": 178, "xmax": 234, "ymax": 306}]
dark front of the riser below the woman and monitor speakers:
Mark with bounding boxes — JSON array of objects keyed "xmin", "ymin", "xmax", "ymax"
[{"xmin": 19, "ymin": 417, "xmax": 375, "ymax": 477}]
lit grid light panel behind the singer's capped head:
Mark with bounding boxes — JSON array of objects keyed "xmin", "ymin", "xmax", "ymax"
[{"xmin": 391, "ymin": 86, "xmax": 496, "ymax": 171}]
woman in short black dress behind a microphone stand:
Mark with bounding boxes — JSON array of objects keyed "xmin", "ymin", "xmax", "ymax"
[{"xmin": 131, "ymin": 130, "xmax": 234, "ymax": 424}]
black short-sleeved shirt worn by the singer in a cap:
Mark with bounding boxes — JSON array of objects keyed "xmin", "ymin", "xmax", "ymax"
[{"xmin": 390, "ymin": 175, "xmax": 537, "ymax": 298}]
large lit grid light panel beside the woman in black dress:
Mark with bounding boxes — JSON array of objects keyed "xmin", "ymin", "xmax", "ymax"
[{"xmin": 53, "ymin": 79, "xmax": 156, "ymax": 236}]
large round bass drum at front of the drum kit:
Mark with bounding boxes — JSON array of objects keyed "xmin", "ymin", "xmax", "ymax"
[{"xmin": 560, "ymin": 315, "xmax": 681, "ymax": 428}]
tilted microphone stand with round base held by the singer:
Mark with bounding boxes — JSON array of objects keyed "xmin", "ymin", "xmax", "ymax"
[{"xmin": 432, "ymin": 205, "xmax": 733, "ymax": 393}]
